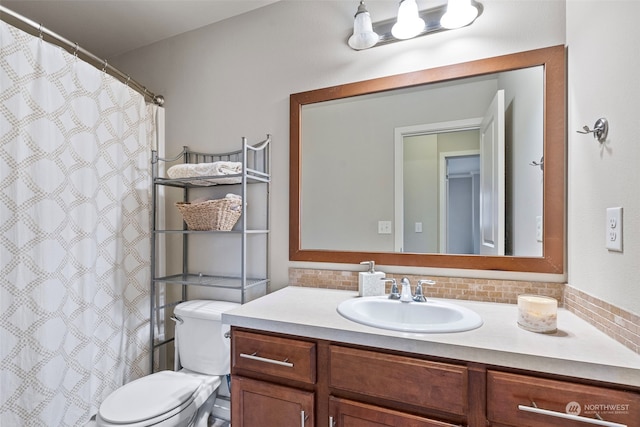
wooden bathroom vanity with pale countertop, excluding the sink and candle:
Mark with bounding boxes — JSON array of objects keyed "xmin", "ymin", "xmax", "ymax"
[{"xmin": 223, "ymin": 287, "xmax": 640, "ymax": 427}]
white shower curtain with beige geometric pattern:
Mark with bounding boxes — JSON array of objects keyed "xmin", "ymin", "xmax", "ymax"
[{"xmin": 0, "ymin": 22, "xmax": 157, "ymax": 427}]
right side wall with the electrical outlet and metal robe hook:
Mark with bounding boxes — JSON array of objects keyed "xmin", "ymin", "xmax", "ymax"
[{"xmin": 567, "ymin": 0, "xmax": 640, "ymax": 314}]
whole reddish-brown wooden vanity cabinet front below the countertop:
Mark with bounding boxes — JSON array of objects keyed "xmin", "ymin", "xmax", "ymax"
[{"xmin": 231, "ymin": 327, "xmax": 640, "ymax": 427}]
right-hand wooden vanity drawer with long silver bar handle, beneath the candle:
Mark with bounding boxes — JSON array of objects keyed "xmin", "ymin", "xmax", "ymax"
[{"xmin": 487, "ymin": 371, "xmax": 640, "ymax": 427}]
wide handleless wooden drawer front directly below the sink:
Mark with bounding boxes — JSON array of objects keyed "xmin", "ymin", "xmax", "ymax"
[{"xmin": 329, "ymin": 345, "xmax": 468, "ymax": 416}]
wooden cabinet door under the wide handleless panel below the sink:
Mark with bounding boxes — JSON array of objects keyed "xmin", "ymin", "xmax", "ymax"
[{"xmin": 329, "ymin": 397, "xmax": 454, "ymax": 427}]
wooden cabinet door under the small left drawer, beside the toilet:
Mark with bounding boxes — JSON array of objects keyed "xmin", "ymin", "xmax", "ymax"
[{"xmin": 231, "ymin": 376, "xmax": 315, "ymax": 427}]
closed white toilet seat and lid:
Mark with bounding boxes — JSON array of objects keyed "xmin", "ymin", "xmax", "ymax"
[{"xmin": 98, "ymin": 371, "xmax": 204, "ymax": 427}]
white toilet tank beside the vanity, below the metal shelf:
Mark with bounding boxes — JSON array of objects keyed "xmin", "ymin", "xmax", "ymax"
[{"xmin": 174, "ymin": 300, "xmax": 240, "ymax": 375}]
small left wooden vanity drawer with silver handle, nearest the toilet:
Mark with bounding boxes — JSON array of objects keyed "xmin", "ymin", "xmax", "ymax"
[{"xmin": 231, "ymin": 330, "xmax": 316, "ymax": 384}]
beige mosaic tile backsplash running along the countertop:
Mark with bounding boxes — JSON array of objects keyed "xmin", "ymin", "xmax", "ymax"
[{"xmin": 289, "ymin": 268, "xmax": 640, "ymax": 354}]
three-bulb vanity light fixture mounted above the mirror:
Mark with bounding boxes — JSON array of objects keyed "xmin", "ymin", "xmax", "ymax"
[{"xmin": 348, "ymin": 0, "xmax": 483, "ymax": 50}]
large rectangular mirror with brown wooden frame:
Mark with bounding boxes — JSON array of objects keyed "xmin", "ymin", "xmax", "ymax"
[{"xmin": 289, "ymin": 46, "xmax": 565, "ymax": 273}]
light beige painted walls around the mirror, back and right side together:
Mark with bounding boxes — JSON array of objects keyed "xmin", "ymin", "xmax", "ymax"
[{"xmin": 114, "ymin": 0, "xmax": 640, "ymax": 313}]
